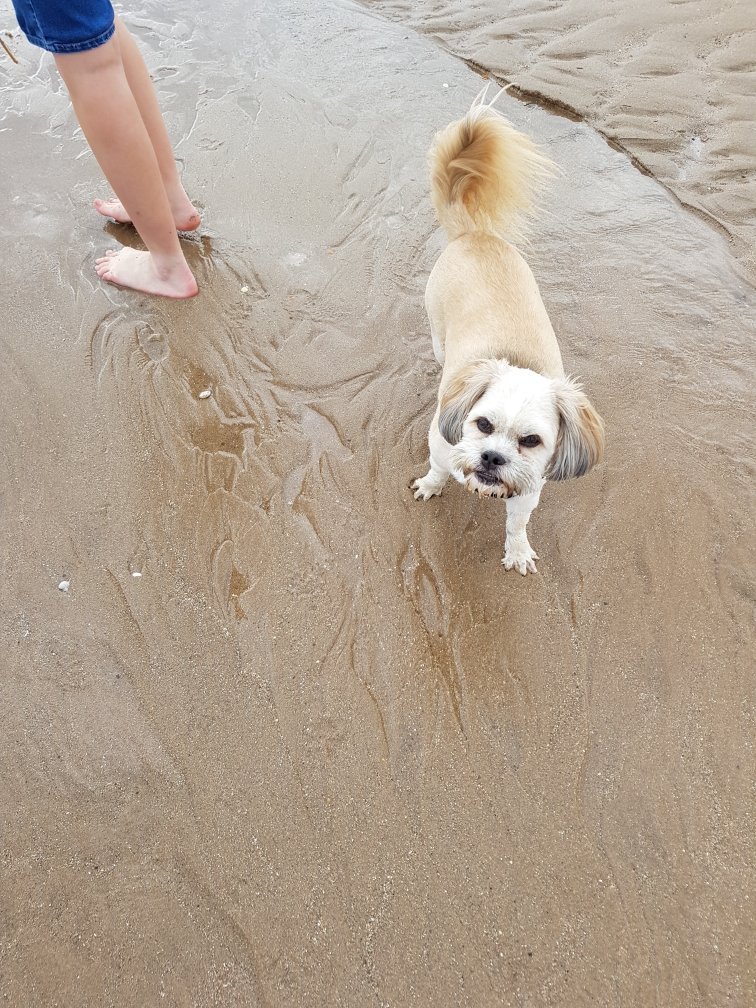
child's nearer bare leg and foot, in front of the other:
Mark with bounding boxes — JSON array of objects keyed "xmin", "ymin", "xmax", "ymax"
[{"xmin": 55, "ymin": 34, "xmax": 197, "ymax": 297}]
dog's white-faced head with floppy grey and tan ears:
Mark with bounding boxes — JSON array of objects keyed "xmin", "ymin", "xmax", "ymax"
[{"xmin": 438, "ymin": 360, "xmax": 604, "ymax": 497}]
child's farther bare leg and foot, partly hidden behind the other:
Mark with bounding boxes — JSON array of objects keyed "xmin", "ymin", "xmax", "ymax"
[{"xmin": 95, "ymin": 17, "xmax": 200, "ymax": 231}]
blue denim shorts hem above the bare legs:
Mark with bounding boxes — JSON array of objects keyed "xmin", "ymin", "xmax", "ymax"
[{"xmin": 12, "ymin": 0, "xmax": 116, "ymax": 52}]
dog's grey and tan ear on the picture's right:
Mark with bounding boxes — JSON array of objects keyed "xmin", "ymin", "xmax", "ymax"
[{"xmin": 546, "ymin": 378, "xmax": 604, "ymax": 480}]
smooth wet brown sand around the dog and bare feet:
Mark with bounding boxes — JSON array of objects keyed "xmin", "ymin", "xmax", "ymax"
[{"xmin": 0, "ymin": 0, "xmax": 756, "ymax": 1008}]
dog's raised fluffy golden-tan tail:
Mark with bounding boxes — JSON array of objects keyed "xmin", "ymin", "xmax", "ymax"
[{"xmin": 429, "ymin": 91, "xmax": 555, "ymax": 241}]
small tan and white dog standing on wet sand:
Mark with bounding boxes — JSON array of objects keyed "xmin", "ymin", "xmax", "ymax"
[{"xmin": 412, "ymin": 95, "xmax": 604, "ymax": 575}]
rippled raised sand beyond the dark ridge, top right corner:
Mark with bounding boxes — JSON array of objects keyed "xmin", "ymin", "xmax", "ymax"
[{"xmin": 358, "ymin": 0, "xmax": 756, "ymax": 282}]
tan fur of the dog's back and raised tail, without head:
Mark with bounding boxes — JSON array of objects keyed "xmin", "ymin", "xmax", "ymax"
[{"xmin": 425, "ymin": 98, "xmax": 564, "ymax": 394}]
